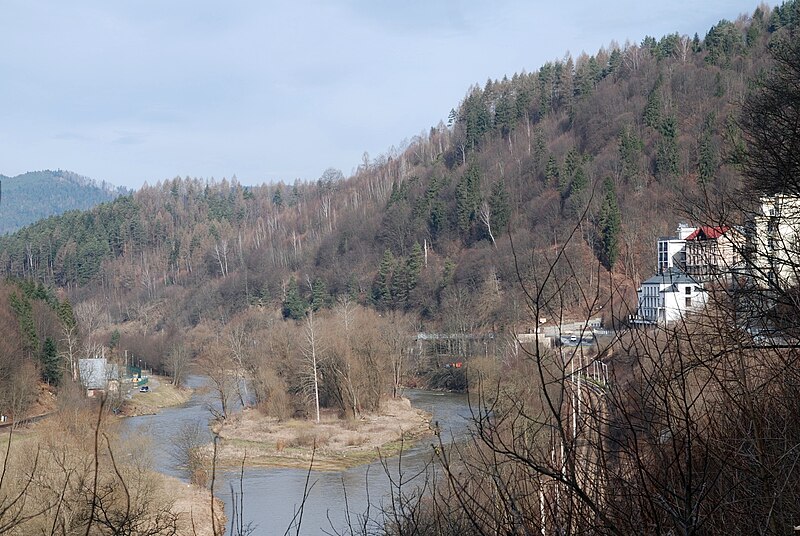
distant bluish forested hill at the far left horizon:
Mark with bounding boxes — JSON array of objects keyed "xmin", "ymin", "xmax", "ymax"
[{"xmin": 0, "ymin": 170, "xmax": 124, "ymax": 235}]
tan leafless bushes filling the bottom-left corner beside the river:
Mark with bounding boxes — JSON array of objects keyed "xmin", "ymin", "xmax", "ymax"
[{"xmin": 0, "ymin": 405, "xmax": 192, "ymax": 536}]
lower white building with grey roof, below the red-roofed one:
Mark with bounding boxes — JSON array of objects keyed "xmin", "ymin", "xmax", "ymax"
[{"xmin": 631, "ymin": 268, "xmax": 707, "ymax": 325}]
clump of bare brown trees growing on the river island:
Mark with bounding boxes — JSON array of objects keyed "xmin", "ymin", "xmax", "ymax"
[{"xmin": 197, "ymin": 298, "xmax": 414, "ymax": 419}]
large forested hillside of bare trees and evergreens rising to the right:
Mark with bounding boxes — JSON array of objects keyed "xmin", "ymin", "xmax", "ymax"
[{"xmin": 0, "ymin": 2, "xmax": 797, "ymax": 356}]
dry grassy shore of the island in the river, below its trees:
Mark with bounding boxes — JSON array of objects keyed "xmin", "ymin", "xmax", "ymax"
[{"xmin": 215, "ymin": 398, "xmax": 431, "ymax": 471}]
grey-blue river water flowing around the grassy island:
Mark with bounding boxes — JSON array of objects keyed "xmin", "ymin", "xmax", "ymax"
[{"xmin": 123, "ymin": 376, "xmax": 470, "ymax": 535}]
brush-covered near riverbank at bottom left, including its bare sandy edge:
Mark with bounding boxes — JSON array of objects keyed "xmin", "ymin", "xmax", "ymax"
[{"xmin": 0, "ymin": 418, "xmax": 226, "ymax": 536}]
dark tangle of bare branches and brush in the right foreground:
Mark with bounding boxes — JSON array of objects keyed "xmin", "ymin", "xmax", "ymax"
[{"xmin": 354, "ymin": 12, "xmax": 800, "ymax": 534}]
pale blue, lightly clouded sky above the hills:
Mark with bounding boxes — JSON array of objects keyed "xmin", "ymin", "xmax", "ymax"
[{"xmin": 0, "ymin": 0, "xmax": 757, "ymax": 188}]
